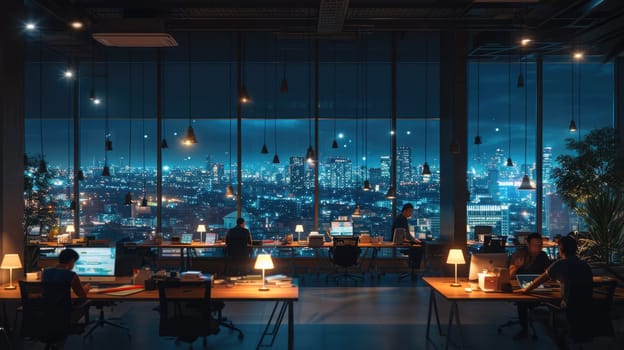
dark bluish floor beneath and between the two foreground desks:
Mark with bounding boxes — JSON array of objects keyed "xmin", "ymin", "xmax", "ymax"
[{"xmin": 6, "ymin": 274, "xmax": 624, "ymax": 350}]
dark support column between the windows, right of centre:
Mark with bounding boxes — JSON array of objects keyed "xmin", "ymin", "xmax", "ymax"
[{"xmin": 440, "ymin": 31, "xmax": 468, "ymax": 248}]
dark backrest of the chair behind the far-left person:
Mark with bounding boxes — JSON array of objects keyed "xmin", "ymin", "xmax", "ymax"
[{"xmin": 19, "ymin": 281, "xmax": 72, "ymax": 341}]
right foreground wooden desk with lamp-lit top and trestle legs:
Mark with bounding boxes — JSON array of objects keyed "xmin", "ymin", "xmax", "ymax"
[{"xmin": 423, "ymin": 277, "xmax": 560, "ymax": 349}]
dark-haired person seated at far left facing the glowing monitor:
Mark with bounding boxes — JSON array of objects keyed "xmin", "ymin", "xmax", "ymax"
[{"xmin": 41, "ymin": 248, "xmax": 89, "ymax": 323}]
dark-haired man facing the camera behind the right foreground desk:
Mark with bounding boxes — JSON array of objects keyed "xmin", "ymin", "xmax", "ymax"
[{"xmin": 509, "ymin": 233, "xmax": 550, "ymax": 339}]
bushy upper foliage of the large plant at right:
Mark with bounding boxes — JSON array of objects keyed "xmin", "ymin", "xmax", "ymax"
[{"xmin": 551, "ymin": 128, "xmax": 624, "ymax": 209}]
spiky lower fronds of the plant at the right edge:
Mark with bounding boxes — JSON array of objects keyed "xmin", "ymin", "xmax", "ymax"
[{"xmin": 577, "ymin": 187, "xmax": 624, "ymax": 264}]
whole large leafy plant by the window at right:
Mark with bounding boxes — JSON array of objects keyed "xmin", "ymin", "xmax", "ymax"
[{"xmin": 551, "ymin": 128, "xmax": 624, "ymax": 264}]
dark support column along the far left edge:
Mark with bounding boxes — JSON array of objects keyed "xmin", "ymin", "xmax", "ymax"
[{"xmin": 0, "ymin": 0, "xmax": 28, "ymax": 276}]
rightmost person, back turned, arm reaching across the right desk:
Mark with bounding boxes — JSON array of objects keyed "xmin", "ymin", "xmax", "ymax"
[{"xmin": 514, "ymin": 236, "xmax": 593, "ymax": 339}]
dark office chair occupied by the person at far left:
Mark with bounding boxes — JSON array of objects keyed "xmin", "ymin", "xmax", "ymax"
[{"xmin": 19, "ymin": 281, "xmax": 89, "ymax": 349}]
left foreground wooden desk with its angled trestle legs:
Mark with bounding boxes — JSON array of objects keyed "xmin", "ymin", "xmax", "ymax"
[{"xmin": 0, "ymin": 277, "xmax": 299, "ymax": 350}]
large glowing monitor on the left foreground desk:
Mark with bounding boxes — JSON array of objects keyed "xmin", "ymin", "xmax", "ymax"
[{"xmin": 73, "ymin": 247, "xmax": 116, "ymax": 282}]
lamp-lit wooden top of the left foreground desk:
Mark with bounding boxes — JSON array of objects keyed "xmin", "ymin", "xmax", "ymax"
[{"xmin": 0, "ymin": 278, "xmax": 299, "ymax": 302}]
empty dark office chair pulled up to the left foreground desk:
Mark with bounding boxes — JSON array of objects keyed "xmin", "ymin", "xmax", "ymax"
[{"xmin": 158, "ymin": 280, "xmax": 219, "ymax": 347}]
